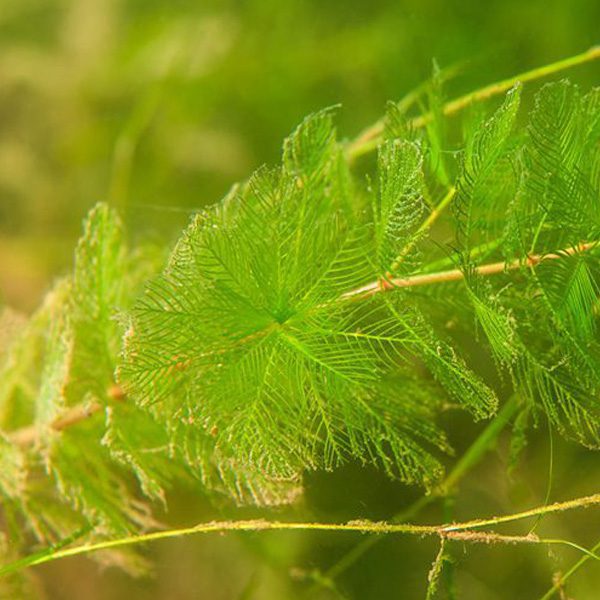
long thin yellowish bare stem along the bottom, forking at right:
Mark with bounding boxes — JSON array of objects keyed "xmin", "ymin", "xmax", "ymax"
[{"xmin": 0, "ymin": 494, "xmax": 600, "ymax": 576}]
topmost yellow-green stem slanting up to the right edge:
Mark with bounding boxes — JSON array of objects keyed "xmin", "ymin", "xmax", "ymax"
[{"xmin": 346, "ymin": 46, "xmax": 600, "ymax": 162}]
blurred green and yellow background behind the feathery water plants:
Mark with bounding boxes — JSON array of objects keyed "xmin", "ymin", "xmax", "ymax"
[{"xmin": 0, "ymin": 0, "xmax": 600, "ymax": 600}]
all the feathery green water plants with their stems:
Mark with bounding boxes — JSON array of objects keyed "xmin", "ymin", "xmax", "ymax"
[{"xmin": 0, "ymin": 38, "xmax": 600, "ymax": 598}]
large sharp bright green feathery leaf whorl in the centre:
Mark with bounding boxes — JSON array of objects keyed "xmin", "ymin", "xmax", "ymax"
[{"xmin": 121, "ymin": 112, "xmax": 495, "ymax": 500}]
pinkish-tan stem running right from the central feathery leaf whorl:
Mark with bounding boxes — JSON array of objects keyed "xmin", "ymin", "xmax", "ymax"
[{"xmin": 341, "ymin": 241, "xmax": 599, "ymax": 299}]
